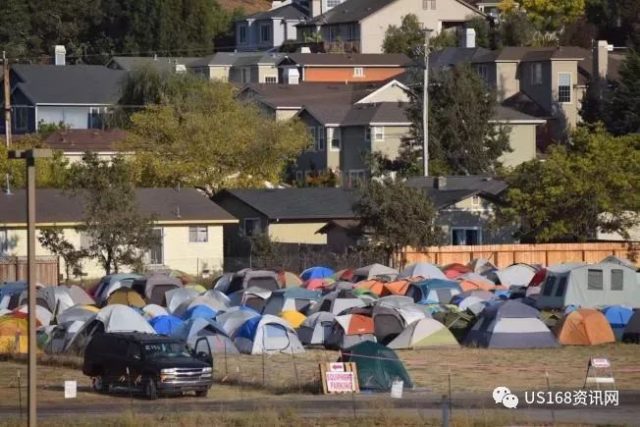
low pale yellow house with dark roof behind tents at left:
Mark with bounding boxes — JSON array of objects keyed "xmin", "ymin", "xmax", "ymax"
[{"xmin": 0, "ymin": 188, "xmax": 238, "ymax": 277}]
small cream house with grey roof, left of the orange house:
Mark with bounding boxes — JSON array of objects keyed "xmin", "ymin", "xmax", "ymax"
[{"xmin": 188, "ymin": 52, "xmax": 284, "ymax": 84}]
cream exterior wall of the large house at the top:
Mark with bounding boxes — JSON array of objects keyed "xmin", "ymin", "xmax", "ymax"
[{"xmin": 360, "ymin": 0, "xmax": 482, "ymax": 53}]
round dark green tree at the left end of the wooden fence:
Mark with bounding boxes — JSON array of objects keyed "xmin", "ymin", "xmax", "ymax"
[{"xmin": 353, "ymin": 179, "xmax": 442, "ymax": 261}]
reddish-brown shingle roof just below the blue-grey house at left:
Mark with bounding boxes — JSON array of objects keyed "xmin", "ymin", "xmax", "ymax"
[{"xmin": 44, "ymin": 129, "xmax": 127, "ymax": 153}]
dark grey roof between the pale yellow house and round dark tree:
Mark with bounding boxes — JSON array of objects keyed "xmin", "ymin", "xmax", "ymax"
[{"xmin": 214, "ymin": 188, "xmax": 358, "ymax": 220}]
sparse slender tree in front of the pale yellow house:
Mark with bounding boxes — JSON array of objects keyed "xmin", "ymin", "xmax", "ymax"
[{"xmin": 68, "ymin": 154, "xmax": 157, "ymax": 274}]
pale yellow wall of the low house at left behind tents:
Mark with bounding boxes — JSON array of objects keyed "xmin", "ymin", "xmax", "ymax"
[{"xmin": 1, "ymin": 224, "xmax": 224, "ymax": 278}]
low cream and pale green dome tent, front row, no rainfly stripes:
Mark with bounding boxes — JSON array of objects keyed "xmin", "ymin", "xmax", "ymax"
[{"xmin": 387, "ymin": 318, "xmax": 459, "ymax": 350}]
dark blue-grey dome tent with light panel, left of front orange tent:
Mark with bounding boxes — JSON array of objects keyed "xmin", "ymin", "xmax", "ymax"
[{"xmin": 463, "ymin": 300, "xmax": 558, "ymax": 348}]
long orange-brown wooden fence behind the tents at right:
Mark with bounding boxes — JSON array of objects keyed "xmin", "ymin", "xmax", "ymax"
[{"xmin": 403, "ymin": 242, "xmax": 640, "ymax": 268}]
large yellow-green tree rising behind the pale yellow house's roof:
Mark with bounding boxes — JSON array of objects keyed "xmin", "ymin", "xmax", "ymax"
[{"xmin": 125, "ymin": 71, "xmax": 310, "ymax": 196}]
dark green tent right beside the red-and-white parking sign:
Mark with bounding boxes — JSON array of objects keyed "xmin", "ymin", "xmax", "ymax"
[{"xmin": 339, "ymin": 341, "xmax": 413, "ymax": 391}]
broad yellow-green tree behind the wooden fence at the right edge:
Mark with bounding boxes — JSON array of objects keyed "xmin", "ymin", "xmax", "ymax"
[{"xmin": 498, "ymin": 127, "xmax": 640, "ymax": 242}]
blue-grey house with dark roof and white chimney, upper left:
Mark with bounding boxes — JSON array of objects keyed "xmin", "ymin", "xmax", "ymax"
[{"xmin": 0, "ymin": 57, "xmax": 126, "ymax": 134}]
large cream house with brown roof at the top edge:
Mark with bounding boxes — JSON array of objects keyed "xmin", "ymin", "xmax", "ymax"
[{"xmin": 298, "ymin": 0, "xmax": 485, "ymax": 53}]
